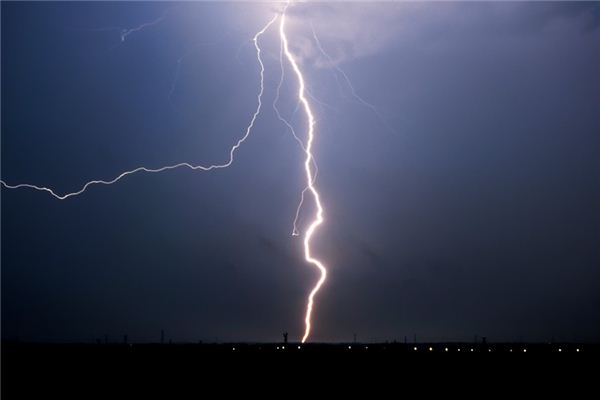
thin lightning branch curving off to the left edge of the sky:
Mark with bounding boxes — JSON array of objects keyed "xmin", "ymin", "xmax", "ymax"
[{"xmin": 0, "ymin": 16, "xmax": 277, "ymax": 200}]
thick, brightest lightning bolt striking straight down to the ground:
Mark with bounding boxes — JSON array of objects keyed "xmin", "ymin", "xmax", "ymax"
[{"xmin": 279, "ymin": 2, "xmax": 327, "ymax": 343}]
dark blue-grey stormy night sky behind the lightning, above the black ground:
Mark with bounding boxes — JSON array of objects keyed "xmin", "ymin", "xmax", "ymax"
[{"xmin": 1, "ymin": 2, "xmax": 600, "ymax": 341}]
